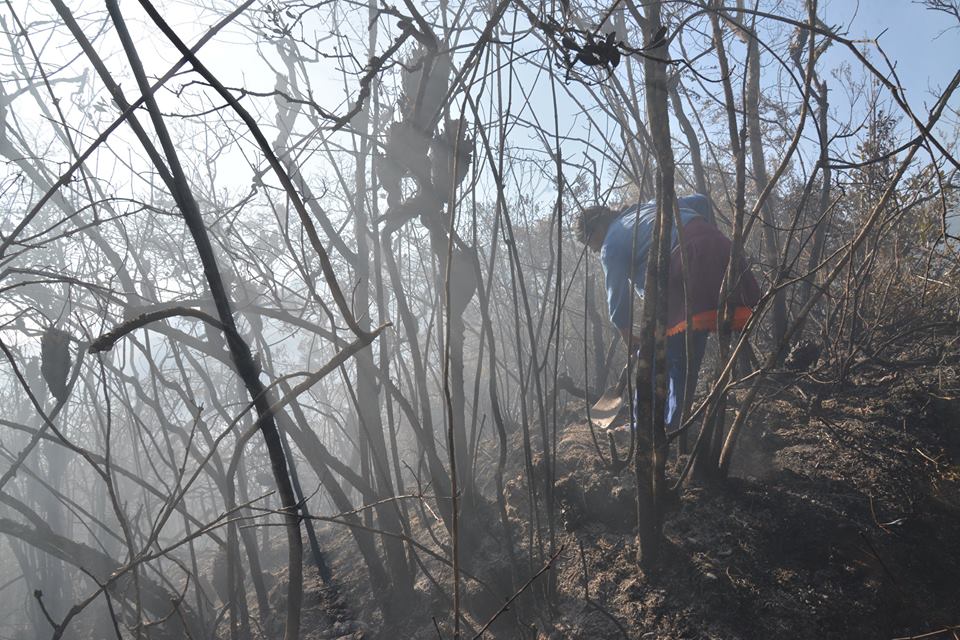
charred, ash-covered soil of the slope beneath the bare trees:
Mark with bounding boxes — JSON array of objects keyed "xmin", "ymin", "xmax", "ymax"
[{"xmin": 292, "ymin": 358, "xmax": 960, "ymax": 640}]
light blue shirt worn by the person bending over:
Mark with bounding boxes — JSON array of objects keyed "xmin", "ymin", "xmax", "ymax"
[{"xmin": 600, "ymin": 194, "xmax": 710, "ymax": 329}]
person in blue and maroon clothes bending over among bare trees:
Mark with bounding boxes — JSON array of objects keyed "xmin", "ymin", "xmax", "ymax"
[{"xmin": 575, "ymin": 194, "xmax": 760, "ymax": 431}]
